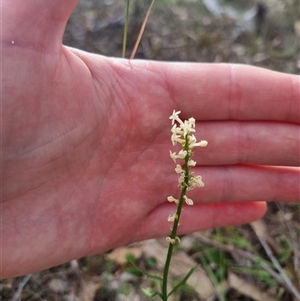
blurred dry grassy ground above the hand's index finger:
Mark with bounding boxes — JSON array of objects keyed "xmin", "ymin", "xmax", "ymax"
[{"xmin": 64, "ymin": 0, "xmax": 300, "ymax": 73}]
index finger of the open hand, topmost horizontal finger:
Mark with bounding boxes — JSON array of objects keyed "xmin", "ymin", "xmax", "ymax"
[{"xmin": 127, "ymin": 61, "xmax": 300, "ymax": 123}]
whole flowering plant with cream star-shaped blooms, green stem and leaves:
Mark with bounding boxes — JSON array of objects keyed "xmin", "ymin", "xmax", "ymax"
[{"xmin": 144, "ymin": 110, "xmax": 208, "ymax": 301}]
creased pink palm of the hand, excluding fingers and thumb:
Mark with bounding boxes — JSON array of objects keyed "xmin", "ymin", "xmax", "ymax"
[{"xmin": 3, "ymin": 37, "xmax": 180, "ymax": 268}]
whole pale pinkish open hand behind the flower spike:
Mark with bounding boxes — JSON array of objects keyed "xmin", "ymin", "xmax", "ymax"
[{"xmin": 0, "ymin": 0, "xmax": 300, "ymax": 278}]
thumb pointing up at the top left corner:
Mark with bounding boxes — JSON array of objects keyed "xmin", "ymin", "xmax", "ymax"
[{"xmin": 1, "ymin": 0, "xmax": 79, "ymax": 51}]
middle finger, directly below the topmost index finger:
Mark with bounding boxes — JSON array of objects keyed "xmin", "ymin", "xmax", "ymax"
[{"xmin": 194, "ymin": 121, "xmax": 300, "ymax": 166}]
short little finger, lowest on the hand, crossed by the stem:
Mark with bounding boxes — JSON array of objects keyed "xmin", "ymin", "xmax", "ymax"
[{"xmin": 133, "ymin": 202, "xmax": 266, "ymax": 240}]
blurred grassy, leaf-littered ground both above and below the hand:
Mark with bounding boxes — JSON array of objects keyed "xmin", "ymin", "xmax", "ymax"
[{"xmin": 0, "ymin": 0, "xmax": 300, "ymax": 301}]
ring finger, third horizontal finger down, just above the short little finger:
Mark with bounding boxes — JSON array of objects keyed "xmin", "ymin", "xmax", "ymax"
[{"xmin": 188, "ymin": 165, "xmax": 300, "ymax": 203}]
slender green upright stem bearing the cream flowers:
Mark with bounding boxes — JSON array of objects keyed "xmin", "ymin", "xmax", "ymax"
[{"xmin": 162, "ymin": 135, "xmax": 190, "ymax": 301}]
